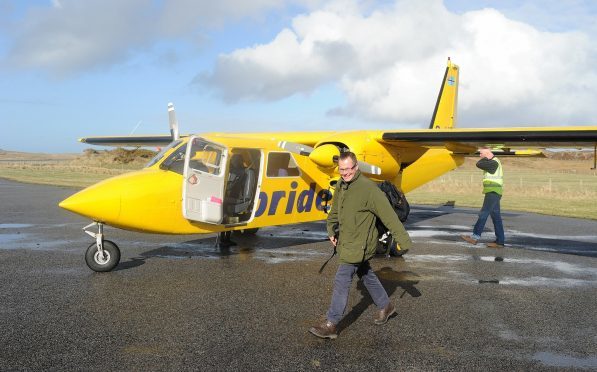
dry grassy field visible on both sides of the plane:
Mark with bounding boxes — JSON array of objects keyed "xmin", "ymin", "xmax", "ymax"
[{"xmin": 0, "ymin": 150, "xmax": 597, "ymax": 219}]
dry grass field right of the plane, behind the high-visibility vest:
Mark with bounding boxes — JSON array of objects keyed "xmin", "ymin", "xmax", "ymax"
[{"xmin": 407, "ymin": 158, "xmax": 597, "ymax": 219}]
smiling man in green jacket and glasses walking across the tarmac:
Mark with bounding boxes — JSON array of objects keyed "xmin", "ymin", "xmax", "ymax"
[{"xmin": 309, "ymin": 152, "xmax": 412, "ymax": 339}]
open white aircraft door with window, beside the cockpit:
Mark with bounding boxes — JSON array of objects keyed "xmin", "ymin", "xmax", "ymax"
[{"xmin": 182, "ymin": 136, "xmax": 228, "ymax": 224}]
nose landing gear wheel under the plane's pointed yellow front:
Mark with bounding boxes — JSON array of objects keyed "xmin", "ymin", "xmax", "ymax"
[{"xmin": 83, "ymin": 222, "xmax": 120, "ymax": 272}]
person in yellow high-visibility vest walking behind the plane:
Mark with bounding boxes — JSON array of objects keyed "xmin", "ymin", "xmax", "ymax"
[{"xmin": 461, "ymin": 147, "xmax": 505, "ymax": 248}]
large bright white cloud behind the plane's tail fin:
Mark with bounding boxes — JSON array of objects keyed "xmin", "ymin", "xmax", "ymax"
[{"xmin": 198, "ymin": 0, "xmax": 597, "ymax": 126}]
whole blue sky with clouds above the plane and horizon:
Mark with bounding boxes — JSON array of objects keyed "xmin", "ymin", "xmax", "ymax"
[{"xmin": 0, "ymin": 0, "xmax": 597, "ymax": 152}]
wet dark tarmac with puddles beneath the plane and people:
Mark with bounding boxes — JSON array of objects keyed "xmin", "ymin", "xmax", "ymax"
[{"xmin": 0, "ymin": 180, "xmax": 597, "ymax": 371}]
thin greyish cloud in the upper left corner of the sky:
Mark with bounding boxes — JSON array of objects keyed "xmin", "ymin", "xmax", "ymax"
[{"xmin": 4, "ymin": 0, "xmax": 318, "ymax": 76}]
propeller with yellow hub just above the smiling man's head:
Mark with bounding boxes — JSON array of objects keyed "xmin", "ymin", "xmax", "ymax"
[{"xmin": 278, "ymin": 141, "xmax": 381, "ymax": 175}]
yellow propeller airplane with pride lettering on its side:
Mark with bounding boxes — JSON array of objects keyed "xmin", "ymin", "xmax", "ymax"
[{"xmin": 59, "ymin": 59, "xmax": 597, "ymax": 271}]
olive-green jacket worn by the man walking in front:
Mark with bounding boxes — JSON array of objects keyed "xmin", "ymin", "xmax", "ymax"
[{"xmin": 327, "ymin": 171, "xmax": 412, "ymax": 264}]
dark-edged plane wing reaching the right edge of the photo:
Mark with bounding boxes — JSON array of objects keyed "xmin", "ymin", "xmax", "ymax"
[{"xmin": 377, "ymin": 126, "xmax": 597, "ymax": 154}]
